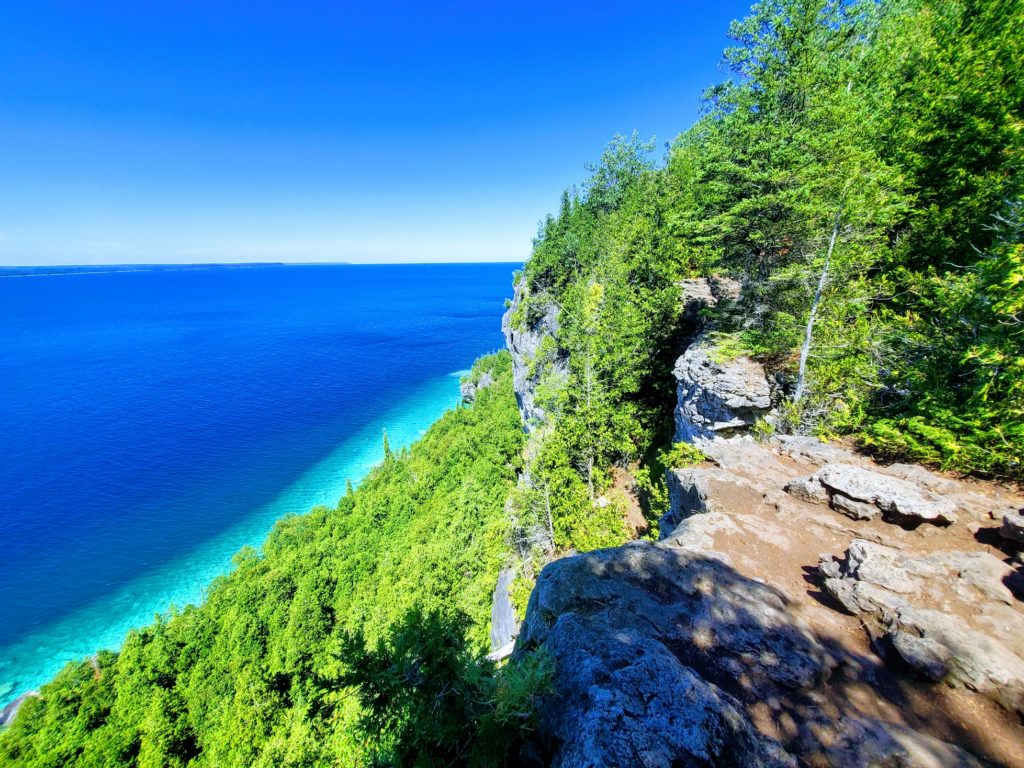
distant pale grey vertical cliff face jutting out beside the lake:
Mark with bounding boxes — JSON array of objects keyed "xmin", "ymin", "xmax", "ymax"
[{"xmin": 502, "ymin": 280, "xmax": 568, "ymax": 432}]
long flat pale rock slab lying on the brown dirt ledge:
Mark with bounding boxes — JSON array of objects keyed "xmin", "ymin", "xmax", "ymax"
[{"xmin": 785, "ymin": 464, "xmax": 956, "ymax": 525}]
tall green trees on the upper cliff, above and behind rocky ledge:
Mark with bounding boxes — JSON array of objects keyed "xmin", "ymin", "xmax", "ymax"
[{"xmin": 512, "ymin": 0, "xmax": 1024, "ymax": 573}]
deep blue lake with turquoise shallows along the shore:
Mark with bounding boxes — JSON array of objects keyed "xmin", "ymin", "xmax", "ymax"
[{"xmin": 0, "ymin": 264, "xmax": 513, "ymax": 705}]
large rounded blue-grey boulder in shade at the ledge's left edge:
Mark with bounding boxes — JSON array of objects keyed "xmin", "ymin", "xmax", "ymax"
[{"xmin": 517, "ymin": 543, "xmax": 811, "ymax": 768}]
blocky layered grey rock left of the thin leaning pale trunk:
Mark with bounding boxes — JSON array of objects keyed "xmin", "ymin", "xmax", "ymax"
[{"xmin": 673, "ymin": 338, "xmax": 771, "ymax": 442}]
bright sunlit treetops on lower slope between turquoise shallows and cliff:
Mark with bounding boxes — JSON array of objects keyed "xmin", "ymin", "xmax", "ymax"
[{"xmin": 0, "ymin": 353, "xmax": 522, "ymax": 768}]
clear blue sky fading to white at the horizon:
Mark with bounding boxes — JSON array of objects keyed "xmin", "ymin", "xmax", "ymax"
[{"xmin": 0, "ymin": 0, "xmax": 750, "ymax": 265}]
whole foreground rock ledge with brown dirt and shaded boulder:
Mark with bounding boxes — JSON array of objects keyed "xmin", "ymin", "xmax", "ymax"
[{"xmin": 517, "ymin": 437, "xmax": 1024, "ymax": 768}]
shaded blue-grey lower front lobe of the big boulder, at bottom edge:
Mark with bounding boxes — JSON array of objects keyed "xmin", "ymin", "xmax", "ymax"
[{"xmin": 540, "ymin": 612, "xmax": 797, "ymax": 768}]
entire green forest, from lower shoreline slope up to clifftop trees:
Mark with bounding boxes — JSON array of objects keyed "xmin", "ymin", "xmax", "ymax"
[{"xmin": 0, "ymin": 0, "xmax": 1024, "ymax": 766}]
